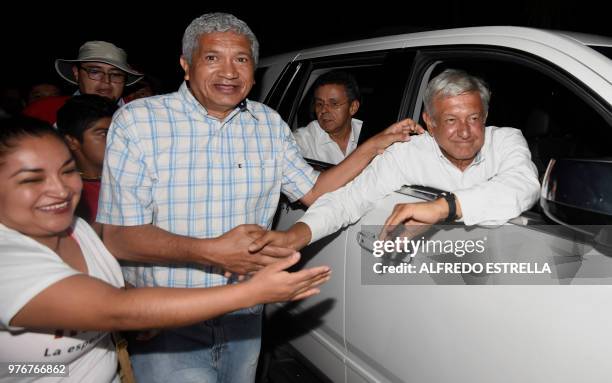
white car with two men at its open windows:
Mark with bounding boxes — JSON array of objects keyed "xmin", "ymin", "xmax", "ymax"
[{"xmin": 258, "ymin": 27, "xmax": 612, "ymax": 383}]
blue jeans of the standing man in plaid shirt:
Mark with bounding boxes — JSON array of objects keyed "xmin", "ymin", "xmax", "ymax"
[{"xmin": 130, "ymin": 305, "xmax": 262, "ymax": 383}]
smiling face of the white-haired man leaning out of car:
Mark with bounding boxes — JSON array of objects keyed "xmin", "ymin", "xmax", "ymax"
[{"xmin": 423, "ymin": 92, "xmax": 486, "ymax": 170}]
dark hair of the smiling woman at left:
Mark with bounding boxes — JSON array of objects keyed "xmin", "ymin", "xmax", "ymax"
[{"xmin": 0, "ymin": 116, "xmax": 64, "ymax": 158}]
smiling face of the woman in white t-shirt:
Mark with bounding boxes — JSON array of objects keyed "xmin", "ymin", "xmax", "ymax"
[{"xmin": 0, "ymin": 134, "xmax": 82, "ymax": 243}]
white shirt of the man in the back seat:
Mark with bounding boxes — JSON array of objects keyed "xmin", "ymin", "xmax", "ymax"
[{"xmin": 293, "ymin": 118, "xmax": 363, "ymax": 165}]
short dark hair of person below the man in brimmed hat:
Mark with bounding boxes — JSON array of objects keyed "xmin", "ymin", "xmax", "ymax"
[{"xmin": 57, "ymin": 94, "xmax": 117, "ymax": 142}]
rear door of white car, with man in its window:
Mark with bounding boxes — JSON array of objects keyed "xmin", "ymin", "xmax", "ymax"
[{"xmin": 266, "ymin": 50, "xmax": 414, "ymax": 381}]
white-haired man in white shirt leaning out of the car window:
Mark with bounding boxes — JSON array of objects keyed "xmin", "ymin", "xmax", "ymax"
[{"xmin": 250, "ymin": 69, "xmax": 540, "ymax": 255}]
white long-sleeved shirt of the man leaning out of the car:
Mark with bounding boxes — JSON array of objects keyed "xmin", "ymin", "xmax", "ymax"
[{"xmin": 300, "ymin": 126, "xmax": 540, "ymax": 242}]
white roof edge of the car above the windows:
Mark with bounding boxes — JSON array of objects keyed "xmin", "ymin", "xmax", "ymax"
[{"xmin": 260, "ymin": 26, "xmax": 612, "ymax": 99}]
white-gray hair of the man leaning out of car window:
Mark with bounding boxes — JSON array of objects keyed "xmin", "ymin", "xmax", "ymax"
[{"xmin": 423, "ymin": 69, "xmax": 491, "ymax": 117}]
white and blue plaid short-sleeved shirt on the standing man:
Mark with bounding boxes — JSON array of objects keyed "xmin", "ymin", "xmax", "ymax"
[{"xmin": 97, "ymin": 83, "xmax": 318, "ymax": 287}]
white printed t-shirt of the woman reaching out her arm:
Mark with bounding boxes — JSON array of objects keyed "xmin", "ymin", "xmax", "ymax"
[{"xmin": 0, "ymin": 218, "xmax": 123, "ymax": 382}]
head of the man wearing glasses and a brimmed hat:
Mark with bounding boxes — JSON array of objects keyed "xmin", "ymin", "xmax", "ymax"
[{"xmin": 55, "ymin": 41, "xmax": 143, "ymax": 106}]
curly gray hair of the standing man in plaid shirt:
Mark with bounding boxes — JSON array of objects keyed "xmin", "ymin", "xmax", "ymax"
[{"xmin": 183, "ymin": 13, "xmax": 259, "ymax": 67}]
